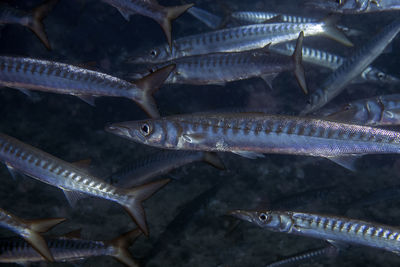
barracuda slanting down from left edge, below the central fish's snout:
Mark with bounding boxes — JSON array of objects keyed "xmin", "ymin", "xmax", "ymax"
[{"xmin": 0, "ymin": 133, "xmax": 169, "ymax": 235}]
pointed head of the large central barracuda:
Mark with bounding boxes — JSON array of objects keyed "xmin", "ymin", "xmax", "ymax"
[{"xmin": 105, "ymin": 119, "xmax": 166, "ymax": 147}]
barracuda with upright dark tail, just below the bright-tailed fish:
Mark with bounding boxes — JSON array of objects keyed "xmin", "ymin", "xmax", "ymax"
[{"xmin": 134, "ymin": 32, "xmax": 308, "ymax": 93}]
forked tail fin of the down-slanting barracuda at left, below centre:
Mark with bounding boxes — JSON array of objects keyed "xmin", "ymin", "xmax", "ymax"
[{"xmin": 121, "ymin": 179, "xmax": 170, "ymax": 235}]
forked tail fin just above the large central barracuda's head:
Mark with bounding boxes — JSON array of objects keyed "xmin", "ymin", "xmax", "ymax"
[{"xmin": 133, "ymin": 64, "xmax": 175, "ymax": 118}]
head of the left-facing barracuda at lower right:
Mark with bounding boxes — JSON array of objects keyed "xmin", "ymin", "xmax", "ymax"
[{"xmin": 229, "ymin": 210, "xmax": 287, "ymax": 232}]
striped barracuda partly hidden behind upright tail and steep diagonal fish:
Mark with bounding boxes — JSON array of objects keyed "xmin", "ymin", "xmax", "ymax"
[{"xmin": 269, "ymin": 43, "xmax": 400, "ymax": 84}]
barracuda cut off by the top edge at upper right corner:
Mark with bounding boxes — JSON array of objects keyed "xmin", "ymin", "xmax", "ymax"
[{"xmin": 306, "ymin": 0, "xmax": 400, "ymax": 14}]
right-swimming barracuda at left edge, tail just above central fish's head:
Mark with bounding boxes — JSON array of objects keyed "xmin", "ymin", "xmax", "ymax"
[{"xmin": 0, "ymin": 56, "xmax": 174, "ymax": 117}]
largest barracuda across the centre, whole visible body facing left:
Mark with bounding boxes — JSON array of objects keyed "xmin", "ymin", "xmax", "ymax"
[{"xmin": 106, "ymin": 113, "xmax": 400, "ymax": 170}]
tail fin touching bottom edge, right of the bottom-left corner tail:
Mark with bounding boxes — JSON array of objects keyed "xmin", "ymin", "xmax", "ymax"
[{"xmin": 107, "ymin": 229, "xmax": 142, "ymax": 267}]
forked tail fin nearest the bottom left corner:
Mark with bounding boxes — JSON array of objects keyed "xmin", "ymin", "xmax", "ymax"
[{"xmin": 23, "ymin": 218, "xmax": 65, "ymax": 261}]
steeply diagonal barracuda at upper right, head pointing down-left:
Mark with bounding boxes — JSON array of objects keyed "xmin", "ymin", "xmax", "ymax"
[{"xmin": 301, "ymin": 19, "xmax": 400, "ymax": 115}]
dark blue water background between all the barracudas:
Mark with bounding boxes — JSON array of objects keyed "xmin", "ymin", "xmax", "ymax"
[{"xmin": 0, "ymin": 0, "xmax": 400, "ymax": 267}]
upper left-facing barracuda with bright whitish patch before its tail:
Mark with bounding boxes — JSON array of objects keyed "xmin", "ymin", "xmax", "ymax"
[{"xmin": 131, "ymin": 20, "xmax": 352, "ymax": 63}]
